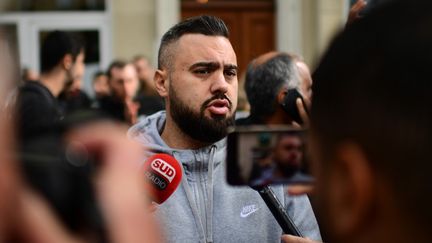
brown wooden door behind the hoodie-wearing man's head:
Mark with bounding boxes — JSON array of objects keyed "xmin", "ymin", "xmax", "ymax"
[{"xmin": 181, "ymin": 0, "xmax": 275, "ymax": 74}]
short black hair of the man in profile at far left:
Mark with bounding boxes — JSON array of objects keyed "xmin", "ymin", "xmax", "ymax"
[{"xmin": 40, "ymin": 30, "xmax": 84, "ymax": 73}]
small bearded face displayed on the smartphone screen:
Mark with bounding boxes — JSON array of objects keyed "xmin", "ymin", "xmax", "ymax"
[{"xmin": 273, "ymin": 135, "xmax": 303, "ymax": 169}]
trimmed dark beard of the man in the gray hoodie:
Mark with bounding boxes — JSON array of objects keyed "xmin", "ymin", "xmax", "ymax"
[{"xmin": 169, "ymin": 88, "xmax": 234, "ymax": 143}]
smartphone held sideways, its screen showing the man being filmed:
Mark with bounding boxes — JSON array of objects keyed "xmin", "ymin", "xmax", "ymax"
[{"xmin": 226, "ymin": 126, "xmax": 314, "ymax": 187}]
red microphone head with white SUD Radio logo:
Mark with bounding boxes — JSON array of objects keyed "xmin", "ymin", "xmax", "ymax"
[{"xmin": 143, "ymin": 154, "xmax": 182, "ymax": 204}]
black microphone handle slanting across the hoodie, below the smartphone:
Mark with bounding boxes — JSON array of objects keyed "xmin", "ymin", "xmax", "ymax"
[{"xmin": 254, "ymin": 186, "xmax": 303, "ymax": 237}]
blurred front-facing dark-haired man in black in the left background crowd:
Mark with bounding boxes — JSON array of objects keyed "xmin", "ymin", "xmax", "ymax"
[{"xmin": 98, "ymin": 60, "xmax": 139, "ymax": 125}]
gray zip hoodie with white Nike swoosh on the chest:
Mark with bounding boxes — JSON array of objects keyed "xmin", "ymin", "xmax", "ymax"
[{"xmin": 129, "ymin": 111, "xmax": 321, "ymax": 243}]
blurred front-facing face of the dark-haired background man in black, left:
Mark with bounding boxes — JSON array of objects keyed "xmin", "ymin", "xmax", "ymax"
[{"xmin": 108, "ymin": 64, "xmax": 139, "ymax": 100}]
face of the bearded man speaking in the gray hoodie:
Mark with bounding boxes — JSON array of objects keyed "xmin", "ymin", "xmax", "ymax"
[{"xmin": 167, "ymin": 34, "xmax": 238, "ymax": 143}]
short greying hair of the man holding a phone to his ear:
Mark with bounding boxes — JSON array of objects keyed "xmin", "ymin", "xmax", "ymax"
[{"xmin": 245, "ymin": 53, "xmax": 299, "ymax": 122}]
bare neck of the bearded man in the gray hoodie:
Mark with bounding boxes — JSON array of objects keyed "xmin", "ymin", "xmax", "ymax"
[{"xmin": 161, "ymin": 109, "xmax": 209, "ymax": 149}]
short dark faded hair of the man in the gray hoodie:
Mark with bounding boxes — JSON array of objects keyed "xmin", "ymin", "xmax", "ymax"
[{"xmin": 158, "ymin": 15, "xmax": 229, "ymax": 69}]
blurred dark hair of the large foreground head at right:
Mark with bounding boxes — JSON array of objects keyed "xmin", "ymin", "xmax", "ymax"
[{"xmin": 311, "ymin": 0, "xmax": 432, "ymax": 225}]
